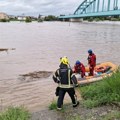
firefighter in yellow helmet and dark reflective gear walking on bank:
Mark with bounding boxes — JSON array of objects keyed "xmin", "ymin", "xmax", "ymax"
[{"xmin": 53, "ymin": 57, "xmax": 79, "ymax": 110}]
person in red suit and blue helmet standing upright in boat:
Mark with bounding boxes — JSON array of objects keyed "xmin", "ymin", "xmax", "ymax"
[{"xmin": 88, "ymin": 49, "xmax": 96, "ymax": 76}]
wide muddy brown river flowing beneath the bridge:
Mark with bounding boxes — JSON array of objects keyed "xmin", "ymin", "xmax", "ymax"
[{"xmin": 0, "ymin": 22, "xmax": 120, "ymax": 109}]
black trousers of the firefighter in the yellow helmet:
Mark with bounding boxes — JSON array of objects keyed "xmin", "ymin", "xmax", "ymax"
[{"xmin": 57, "ymin": 88, "xmax": 77, "ymax": 108}]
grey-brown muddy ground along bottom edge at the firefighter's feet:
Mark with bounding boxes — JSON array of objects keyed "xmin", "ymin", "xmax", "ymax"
[{"xmin": 31, "ymin": 104, "xmax": 120, "ymax": 120}]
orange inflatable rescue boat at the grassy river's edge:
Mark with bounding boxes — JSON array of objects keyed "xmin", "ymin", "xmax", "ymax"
[{"xmin": 76, "ymin": 62, "xmax": 118, "ymax": 85}]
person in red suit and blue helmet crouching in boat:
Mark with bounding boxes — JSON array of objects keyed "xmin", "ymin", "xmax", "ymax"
[{"xmin": 73, "ymin": 60, "xmax": 85, "ymax": 78}]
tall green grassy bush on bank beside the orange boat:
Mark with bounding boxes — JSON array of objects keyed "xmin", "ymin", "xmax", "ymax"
[{"xmin": 80, "ymin": 69, "xmax": 120, "ymax": 108}]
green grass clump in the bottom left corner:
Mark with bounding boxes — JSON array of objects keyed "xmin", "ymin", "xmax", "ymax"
[{"xmin": 0, "ymin": 107, "xmax": 30, "ymax": 120}]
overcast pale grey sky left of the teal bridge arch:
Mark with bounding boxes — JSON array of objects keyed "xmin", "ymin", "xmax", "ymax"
[{"xmin": 0, "ymin": 0, "xmax": 83, "ymax": 16}]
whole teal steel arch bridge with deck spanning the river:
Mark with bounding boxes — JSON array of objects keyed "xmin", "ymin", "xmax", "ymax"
[{"xmin": 59, "ymin": 0, "xmax": 120, "ymax": 19}]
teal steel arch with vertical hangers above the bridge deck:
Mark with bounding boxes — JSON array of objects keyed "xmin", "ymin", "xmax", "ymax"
[{"xmin": 74, "ymin": 0, "xmax": 120, "ymax": 15}]
